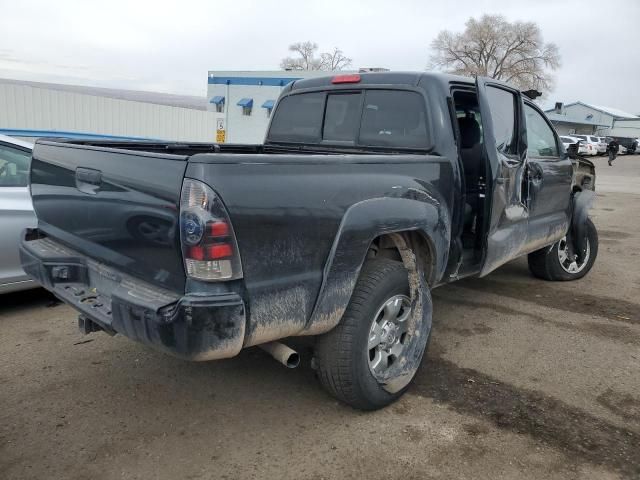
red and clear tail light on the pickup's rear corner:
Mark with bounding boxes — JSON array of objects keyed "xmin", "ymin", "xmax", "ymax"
[{"xmin": 180, "ymin": 178, "xmax": 242, "ymax": 281}]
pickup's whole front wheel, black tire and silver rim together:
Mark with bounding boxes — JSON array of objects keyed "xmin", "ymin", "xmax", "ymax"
[{"xmin": 529, "ymin": 218, "xmax": 598, "ymax": 281}]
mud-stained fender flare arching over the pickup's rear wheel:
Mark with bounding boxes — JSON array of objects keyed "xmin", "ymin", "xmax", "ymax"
[{"xmin": 300, "ymin": 191, "xmax": 451, "ymax": 335}]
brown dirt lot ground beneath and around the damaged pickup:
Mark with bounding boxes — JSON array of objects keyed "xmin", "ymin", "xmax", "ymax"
[{"xmin": 0, "ymin": 156, "xmax": 640, "ymax": 480}]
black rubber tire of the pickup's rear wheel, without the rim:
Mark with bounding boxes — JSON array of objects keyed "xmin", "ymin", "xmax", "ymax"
[{"xmin": 315, "ymin": 258, "xmax": 431, "ymax": 410}]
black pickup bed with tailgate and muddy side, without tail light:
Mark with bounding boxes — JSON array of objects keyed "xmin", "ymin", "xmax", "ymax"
[{"xmin": 31, "ymin": 140, "xmax": 456, "ymax": 344}]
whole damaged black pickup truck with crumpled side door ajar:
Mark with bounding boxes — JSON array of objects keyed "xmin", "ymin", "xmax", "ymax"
[{"xmin": 21, "ymin": 73, "xmax": 598, "ymax": 409}]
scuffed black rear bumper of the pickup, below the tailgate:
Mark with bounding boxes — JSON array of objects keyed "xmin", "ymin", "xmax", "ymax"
[{"xmin": 20, "ymin": 230, "xmax": 246, "ymax": 361}]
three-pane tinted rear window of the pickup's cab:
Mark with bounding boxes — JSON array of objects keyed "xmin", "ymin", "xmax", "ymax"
[{"xmin": 268, "ymin": 90, "xmax": 429, "ymax": 148}]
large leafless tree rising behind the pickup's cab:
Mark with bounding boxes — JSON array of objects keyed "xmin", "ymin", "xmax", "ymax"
[{"xmin": 429, "ymin": 15, "xmax": 560, "ymax": 92}]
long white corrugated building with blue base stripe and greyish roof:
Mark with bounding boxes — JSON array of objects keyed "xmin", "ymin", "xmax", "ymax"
[{"xmin": 0, "ymin": 79, "xmax": 216, "ymax": 142}]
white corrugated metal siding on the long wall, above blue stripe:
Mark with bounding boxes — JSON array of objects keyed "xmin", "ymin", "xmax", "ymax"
[{"xmin": 0, "ymin": 84, "xmax": 216, "ymax": 142}]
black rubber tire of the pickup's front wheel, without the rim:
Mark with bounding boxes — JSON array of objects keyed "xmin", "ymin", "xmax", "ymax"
[{"xmin": 529, "ymin": 218, "xmax": 598, "ymax": 282}]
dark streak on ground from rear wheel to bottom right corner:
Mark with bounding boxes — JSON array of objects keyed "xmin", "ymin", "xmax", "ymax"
[{"xmin": 410, "ymin": 357, "xmax": 640, "ymax": 478}]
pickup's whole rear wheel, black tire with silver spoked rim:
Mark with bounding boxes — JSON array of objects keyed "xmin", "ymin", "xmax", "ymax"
[{"xmin": 316, "ymin": 259, "xmax": 431, "ymax": 410}]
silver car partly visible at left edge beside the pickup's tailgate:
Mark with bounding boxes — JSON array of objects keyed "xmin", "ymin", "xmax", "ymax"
[{"xmin": 0, "ymin": 135, "xmax": 37, "ymax": 293}]
